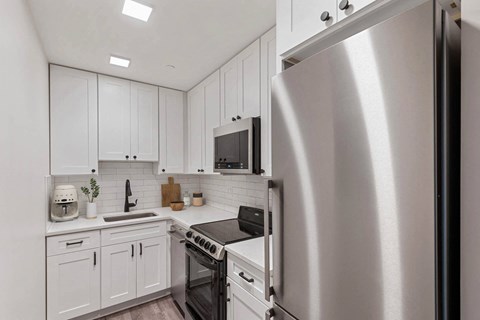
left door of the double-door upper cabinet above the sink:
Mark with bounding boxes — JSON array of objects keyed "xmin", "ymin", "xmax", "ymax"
[{"xmin": 98, "ymin": 75, "xmax": 131, "ymax": 160}]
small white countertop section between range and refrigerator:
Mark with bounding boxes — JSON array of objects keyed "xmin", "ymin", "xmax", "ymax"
[{"xmin": 225, "ymin": 236, "xmax": 273, "ymax": 272}]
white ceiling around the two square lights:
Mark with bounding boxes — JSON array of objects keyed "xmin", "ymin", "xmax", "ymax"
[{"xmin": 27, "ymin": 0, "xmax": 275, "ymax": 90}]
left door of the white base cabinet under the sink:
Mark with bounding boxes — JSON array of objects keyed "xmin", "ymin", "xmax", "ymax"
[{"xmin": 102, "ymin": 242, "xmax": 137, "ymax": 308}]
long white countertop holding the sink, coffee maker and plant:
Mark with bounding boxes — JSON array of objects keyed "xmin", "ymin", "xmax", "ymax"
[{"xmin": 46, "ymin": 205, "xmax": 237, "ymax": 236}]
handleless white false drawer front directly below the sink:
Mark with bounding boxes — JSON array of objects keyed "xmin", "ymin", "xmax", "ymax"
[{"xmin": 102, "ymin": 221, "xmax": 167, "ymax": 246}]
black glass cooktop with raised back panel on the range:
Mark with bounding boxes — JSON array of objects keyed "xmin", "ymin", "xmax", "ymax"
[{"xmin": 192, "ymin": 207, "xmax": 271, "ymax": 245}]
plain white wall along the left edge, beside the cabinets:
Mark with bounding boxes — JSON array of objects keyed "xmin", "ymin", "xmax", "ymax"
[{"xmin": 0, "ymin": 0, "xmax": 49, "ymax": 320}]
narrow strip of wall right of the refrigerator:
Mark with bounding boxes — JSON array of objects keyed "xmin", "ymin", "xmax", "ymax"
[{"xmin": 461, "ymin": 0, "xmax": 480, "ymax": 320}]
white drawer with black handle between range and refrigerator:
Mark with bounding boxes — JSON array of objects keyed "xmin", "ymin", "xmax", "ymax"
[{"xmin": 227, "ymin": 253, "xmax": 273, "ymax": 306}]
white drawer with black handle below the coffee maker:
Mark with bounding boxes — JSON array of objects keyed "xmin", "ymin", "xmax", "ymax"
[{"xmin": 47, "ymin": 231, "xmax": 100, "ymax": 257}]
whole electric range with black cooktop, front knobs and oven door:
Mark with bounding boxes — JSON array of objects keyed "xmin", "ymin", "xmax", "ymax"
[{"xmin": 185, "ymin": 206, "xmax": 271, "ymax": 320}]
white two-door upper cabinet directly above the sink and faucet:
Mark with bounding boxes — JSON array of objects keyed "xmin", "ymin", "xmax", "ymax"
[{"xmin": 98, "ymin": 75, "xmax": 158, "ymax": 162}]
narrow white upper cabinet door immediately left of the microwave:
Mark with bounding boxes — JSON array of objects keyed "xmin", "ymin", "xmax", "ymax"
[{"xmin": 203, "ymin": 71, "xmax": 220, "ymax": 173}]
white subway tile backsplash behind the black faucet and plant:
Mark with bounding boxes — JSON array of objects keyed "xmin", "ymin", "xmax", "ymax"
[{"xmin": 54, "ymin": 161, "xmax": 200, "ymax": 214}]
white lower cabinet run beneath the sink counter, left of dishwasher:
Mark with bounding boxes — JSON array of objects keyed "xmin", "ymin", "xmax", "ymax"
[{"xmin": 47, "ymin": 221, "xmax": 170, "ymax": 320}]
